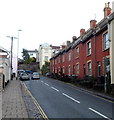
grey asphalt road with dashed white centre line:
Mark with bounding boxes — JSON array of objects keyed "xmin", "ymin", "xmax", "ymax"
[{"xmin": 25, "ymin": 76, "xmax": 112, "ymax": 120}]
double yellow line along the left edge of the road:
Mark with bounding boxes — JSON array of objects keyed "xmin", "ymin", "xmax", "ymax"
[{"xmin": 23, "ymin": 83, "xmax": 49, "ymax": 120}]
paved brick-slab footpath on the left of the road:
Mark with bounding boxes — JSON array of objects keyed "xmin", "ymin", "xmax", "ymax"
[{"xmin": 2, "ymin": 79, "xmax": 28, "ymax": 118}]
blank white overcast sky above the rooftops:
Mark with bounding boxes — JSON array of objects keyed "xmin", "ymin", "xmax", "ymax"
[{"xmin": 0, "ymin": 0, "xmax": 114, "ymax": 57}]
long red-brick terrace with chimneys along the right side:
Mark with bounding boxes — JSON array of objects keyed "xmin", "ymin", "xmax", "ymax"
[{"xmin": 50, "ymin": 3, "xmax": 114, "ymax": 86}]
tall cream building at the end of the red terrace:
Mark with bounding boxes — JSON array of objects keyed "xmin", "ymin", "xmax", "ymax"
[{"xmin": 39, "ymin": 43, "xmax": 52, "ymax": 69}]
